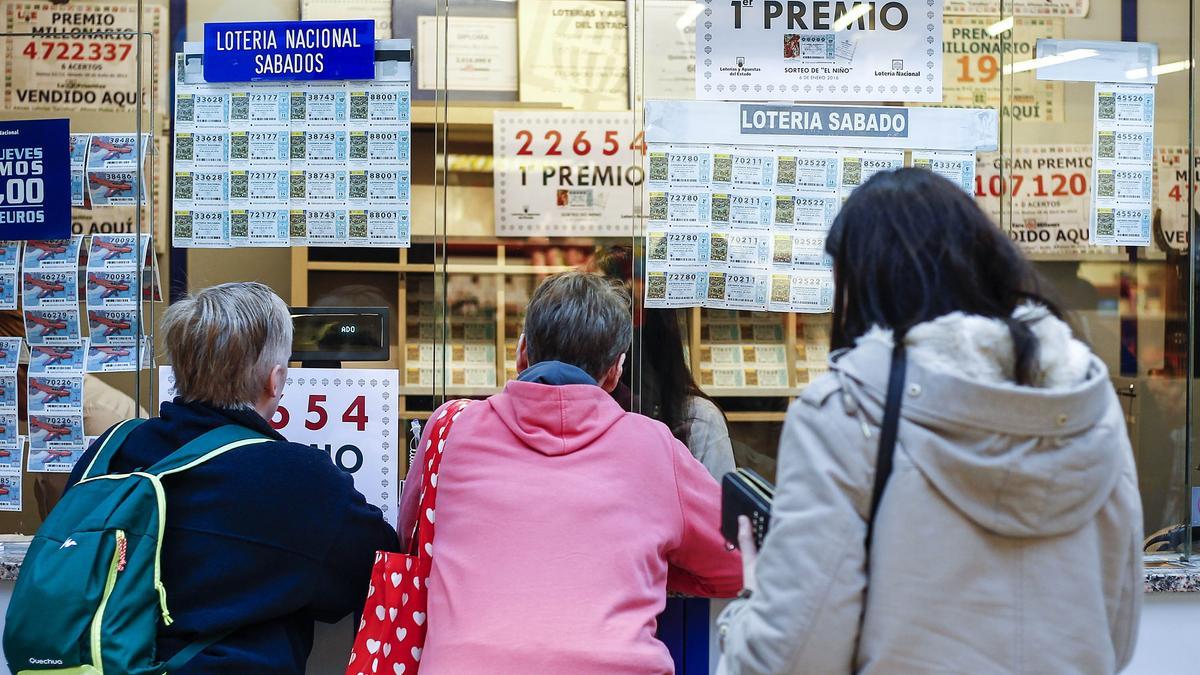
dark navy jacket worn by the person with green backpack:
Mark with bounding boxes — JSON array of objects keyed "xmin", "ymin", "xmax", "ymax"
[{"xmin": 67, "ymin": 400, "xmax": 397, "ymax": 675}]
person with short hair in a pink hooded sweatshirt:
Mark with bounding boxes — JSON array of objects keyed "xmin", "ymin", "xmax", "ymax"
[{"xmin": 400, "ymin": 271, "xmax": 742, "ymax": 675}]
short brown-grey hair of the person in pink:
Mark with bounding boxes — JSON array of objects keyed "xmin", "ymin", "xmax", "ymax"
[{"xmin": 524, "ymin": 271, "xmax": 634, "ymax": 380}]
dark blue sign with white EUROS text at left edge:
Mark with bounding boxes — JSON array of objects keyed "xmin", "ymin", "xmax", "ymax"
[{"xmin": 0, "ymin": 119, "xmax": 71, "ymax": 239}]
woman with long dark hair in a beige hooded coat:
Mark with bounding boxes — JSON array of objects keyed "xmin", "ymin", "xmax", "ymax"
[{"xmin": 719, "ymin": 169, "xmax": 1142, "ymax": 674}]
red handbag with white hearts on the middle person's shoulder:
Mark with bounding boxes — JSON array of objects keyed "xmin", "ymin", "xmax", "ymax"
[{"xmin": 346, "ymin": 400, "xmax": 470, "ymax": 675}]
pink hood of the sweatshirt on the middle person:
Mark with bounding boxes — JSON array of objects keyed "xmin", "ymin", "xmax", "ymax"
[{"xmin": 487, "ymin": 381, "xmax": 625, "ymax": 455}]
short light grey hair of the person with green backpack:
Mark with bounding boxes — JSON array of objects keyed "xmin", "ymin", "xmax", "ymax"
[{"xmin": 162, "ymin": 282, "xmax": 292, "ymax": 408}]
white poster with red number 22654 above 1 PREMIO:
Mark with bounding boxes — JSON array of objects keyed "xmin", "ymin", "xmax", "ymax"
[{"xmin": 492, "ymin": 110, "xmax": 646, "ymax": 237}]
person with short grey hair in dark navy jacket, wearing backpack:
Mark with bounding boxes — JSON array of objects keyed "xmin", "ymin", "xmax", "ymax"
[{"xmin": 67, "ymin": 282, "xmax": 397, "ymax": 675}]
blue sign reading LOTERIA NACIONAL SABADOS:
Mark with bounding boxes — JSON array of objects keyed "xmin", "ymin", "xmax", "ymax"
[{"xmin": 204, "ymin": 19, "xmax": 374, "ymax": 83}]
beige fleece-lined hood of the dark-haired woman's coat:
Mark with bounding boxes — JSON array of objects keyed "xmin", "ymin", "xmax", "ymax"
[{"xmin": 833, "ymin": 305, "xmax": 1127, "ymax": 537}]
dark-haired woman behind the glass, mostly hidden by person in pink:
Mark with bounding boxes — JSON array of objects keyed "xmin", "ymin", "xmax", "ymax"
[{"xmin": 589, "ymin": 245, "xmax": 734, "ymax": 482}]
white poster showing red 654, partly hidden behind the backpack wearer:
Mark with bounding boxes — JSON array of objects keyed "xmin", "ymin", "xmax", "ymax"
[{"xmin": 158, "ymin": 366, "xmax": 408, "ymax": 526}]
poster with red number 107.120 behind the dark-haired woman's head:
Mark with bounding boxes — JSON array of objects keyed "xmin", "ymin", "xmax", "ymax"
[{"xmin": 974, "ymin": 144, "xmax": 1118, "ymax": 261}]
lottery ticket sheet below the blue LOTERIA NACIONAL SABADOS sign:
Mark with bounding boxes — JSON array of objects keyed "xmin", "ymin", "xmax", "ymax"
[{"xmin": 172, "ymin": 41, "xmax": 412, "ymax": 247}]
